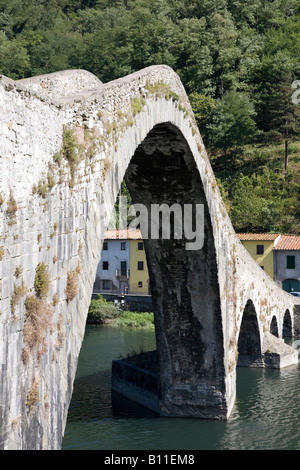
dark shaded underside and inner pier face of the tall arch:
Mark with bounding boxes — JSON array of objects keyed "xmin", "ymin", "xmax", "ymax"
[{"xmin": 119, "ymin": 123, "xmax": 227, "ymax": 418}]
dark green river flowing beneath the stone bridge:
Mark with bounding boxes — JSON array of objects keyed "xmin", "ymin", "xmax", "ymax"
[{"xmin": 62, "ymin": 326, "xmax": 300, "ymax": 450}]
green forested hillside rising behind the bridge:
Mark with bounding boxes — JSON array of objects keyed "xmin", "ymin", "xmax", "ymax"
[{"xmin": 0, "ymin": 0, "xmax": 300, "ymax": 233}]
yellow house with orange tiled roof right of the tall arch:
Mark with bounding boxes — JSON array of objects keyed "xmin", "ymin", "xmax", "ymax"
[{"xmin": 237, "ymin": 233, "xmax": 281, "ymax": 279}]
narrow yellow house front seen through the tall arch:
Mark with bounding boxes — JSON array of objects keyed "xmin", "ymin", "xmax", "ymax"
[{"xmin": 129, "ymin": 230, "xmax": 150, "ymax": 295}]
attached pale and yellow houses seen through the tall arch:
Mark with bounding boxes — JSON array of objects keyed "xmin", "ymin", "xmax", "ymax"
[{"xmin": 93, "ymin": 229, "xmax": 149, "ymax": 295}]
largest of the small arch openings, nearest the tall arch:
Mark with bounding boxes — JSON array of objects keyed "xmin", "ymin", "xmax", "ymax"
[{"xmin": 237, "ymin": 300, "xmax": 261, "ymax": 367}]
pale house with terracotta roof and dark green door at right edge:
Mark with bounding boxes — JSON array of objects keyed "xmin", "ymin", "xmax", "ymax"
[{"xmin": 273, "ymin": 235, "xmax": 300, "ymax": 292}]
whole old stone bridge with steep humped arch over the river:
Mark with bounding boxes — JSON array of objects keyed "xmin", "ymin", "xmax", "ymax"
[{"xmin": 0, "ymin": 66, "xmax": 299, "ymax": 450}]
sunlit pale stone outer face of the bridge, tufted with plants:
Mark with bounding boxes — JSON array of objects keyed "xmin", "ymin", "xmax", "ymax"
[{"xmin": 0, "ymin": 66, "xmax": 298, "ymax": 449}]
